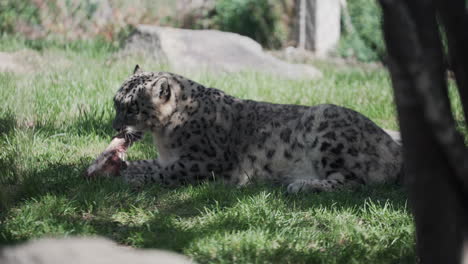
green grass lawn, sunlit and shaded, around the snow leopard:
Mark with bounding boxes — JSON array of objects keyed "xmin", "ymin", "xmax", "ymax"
[{"xmin": 0, "ymin": 37, "xmax": 446, "ymax": 263}]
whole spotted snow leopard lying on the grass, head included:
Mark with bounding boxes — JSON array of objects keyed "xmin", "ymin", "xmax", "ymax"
[{"xmin": 109, "ymin": 68, "xmax": 401, "ymax": 193}]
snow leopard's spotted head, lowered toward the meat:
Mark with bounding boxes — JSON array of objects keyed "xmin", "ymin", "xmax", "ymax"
[{"xmin": 112, "ymin": 65, "xmax": 187, "ymax": 136}]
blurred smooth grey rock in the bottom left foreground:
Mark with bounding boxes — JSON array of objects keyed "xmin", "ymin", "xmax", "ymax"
[{"xmin": 0, "ymin": 237, "xmax": 194, "ymax": 264}]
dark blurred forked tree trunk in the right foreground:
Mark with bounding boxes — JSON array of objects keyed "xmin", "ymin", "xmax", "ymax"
[{"xmin": 380, "ymin": 0, "xmax": 468, "ymax": 263}]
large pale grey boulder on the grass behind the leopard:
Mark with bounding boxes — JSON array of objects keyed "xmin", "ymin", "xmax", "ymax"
[{"xmin": 124, "ymin": 25, "xmax": 321, "ymax": 79}]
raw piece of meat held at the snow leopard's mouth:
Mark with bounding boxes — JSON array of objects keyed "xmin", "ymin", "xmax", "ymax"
[{"xmin": 85, "ymin": 134, "xmax": 131, "ymax": 178}]
